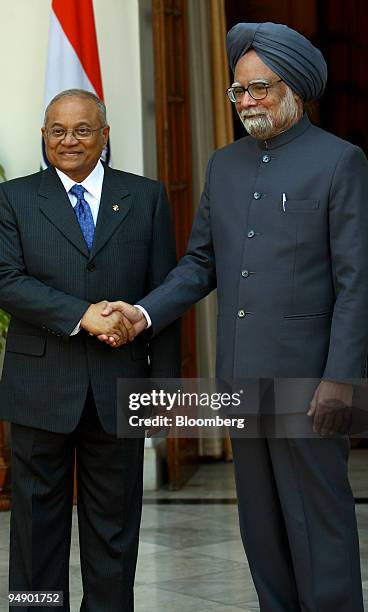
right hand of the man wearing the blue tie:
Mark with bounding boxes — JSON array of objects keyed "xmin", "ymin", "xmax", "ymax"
[{"xmin": 81, "ymin": 300, "xmax": 135, "ymax": 346}]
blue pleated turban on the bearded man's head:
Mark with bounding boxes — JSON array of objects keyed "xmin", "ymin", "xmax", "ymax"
[{"xmin": 226, "ymin": 23, "xmax": 327, "ymax": 102}]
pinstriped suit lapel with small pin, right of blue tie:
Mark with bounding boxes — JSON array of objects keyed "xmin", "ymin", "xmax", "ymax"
[{"xmin": 91, "ymin": 166, "xmax": 132, "ymax": 258}]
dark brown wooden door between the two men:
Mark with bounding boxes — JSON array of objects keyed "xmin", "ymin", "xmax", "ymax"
[{"xmin": 152, "ymin": 0, "xmax": 198, "ymax": 488}]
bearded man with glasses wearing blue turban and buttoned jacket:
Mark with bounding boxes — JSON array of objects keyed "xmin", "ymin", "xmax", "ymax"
[{"xmin": 100, "ymin": 23, "xmax": 368, "ymax": 612}]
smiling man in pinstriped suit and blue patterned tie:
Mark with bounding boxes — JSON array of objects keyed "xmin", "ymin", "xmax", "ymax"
[{"xmin": 0, "ymin": 90, "xmax": 179, "ymax": 612}]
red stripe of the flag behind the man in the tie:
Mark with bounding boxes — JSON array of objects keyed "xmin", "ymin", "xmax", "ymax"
[{"xmin": 52, "ymin": 0, "xmax": 103, "ymax": 100}]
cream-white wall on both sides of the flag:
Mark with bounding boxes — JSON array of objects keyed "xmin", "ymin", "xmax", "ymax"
[{"xmin": 0, "ymin": 0, "xmax": 144, "ymax": 178}]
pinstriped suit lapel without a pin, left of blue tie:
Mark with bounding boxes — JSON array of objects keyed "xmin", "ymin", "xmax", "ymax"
[{"xmin": 38, "ymin": 167, "xmax": 90, "ymax": 258}]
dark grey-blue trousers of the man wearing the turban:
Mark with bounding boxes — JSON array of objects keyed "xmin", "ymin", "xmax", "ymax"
[{"xmin": 232, "ymin": 438, "xmax": 363, "ymax": 612}]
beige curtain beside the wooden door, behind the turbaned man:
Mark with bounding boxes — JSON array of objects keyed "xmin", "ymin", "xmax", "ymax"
[{"xmin": 188, "ymin": 0, "xmax": 233, "ymax": 458}]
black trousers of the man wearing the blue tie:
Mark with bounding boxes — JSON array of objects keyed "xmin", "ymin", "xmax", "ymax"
[{"xmin": 9, "ymin": 392, "xmax": 144, "ymax": 612}]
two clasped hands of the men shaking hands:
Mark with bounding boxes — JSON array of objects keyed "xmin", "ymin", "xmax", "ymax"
[{"xmin": 80, "ymin": 300, "xmax": 147, "ymax": 348}]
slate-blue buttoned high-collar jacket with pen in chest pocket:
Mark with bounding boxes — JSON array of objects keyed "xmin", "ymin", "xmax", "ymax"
[{"xmin": 140, "ymin": 115, "xmax": 368, "ymax": 380}]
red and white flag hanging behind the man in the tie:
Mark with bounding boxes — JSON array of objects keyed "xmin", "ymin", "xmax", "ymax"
[{"xmin": 42, "ymin": 0, "xmax": 110, "ymax": 168}]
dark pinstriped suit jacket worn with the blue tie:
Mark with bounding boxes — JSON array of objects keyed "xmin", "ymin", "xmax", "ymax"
[{"xmin": 0, "ymin": 167, "xmax": 179, "ymax": 433}]
